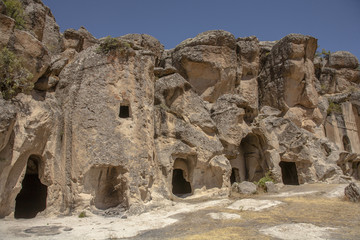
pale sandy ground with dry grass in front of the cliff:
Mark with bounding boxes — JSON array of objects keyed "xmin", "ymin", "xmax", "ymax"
[{"xmin": 0, "ymin": 183, "xmax": 360, "ymax": 240}]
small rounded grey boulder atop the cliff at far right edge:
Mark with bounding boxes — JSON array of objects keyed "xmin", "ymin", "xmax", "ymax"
[{"xmin": 329, "ymin": 51, "xmax": 359, "ymax": 69}]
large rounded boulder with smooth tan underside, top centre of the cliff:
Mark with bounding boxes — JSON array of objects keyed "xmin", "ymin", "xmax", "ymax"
[{"xmin": 172, "ymin": 30, "xmax": 237, "ymax": 102}]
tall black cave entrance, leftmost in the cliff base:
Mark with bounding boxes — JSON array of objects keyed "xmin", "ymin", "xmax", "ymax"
[{"xmin": 14, "ymin": 155, "xmax": 47, "ymax": 218}]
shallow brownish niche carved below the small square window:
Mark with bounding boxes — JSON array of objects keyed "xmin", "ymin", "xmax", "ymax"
[{"xmin": 84, "ymin": 166, "xmax": 127, "ymax": 210}]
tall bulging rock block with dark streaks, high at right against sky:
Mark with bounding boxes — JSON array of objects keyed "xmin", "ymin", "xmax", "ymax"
[{"xmin": 258, "ymin": 34, "xmax": 318, "ymax": 112}]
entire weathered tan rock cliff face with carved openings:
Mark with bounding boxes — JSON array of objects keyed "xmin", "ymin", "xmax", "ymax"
[{"xmin": 0, "ymin": 0, "xmax": 360, "ymax": 217}]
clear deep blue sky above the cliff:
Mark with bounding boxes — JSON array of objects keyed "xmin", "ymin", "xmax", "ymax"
[{"xmin": 43, "ymin": 0, "xmax": 360, "ymax": 59}]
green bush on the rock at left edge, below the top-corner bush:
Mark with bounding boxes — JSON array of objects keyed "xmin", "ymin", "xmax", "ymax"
[{"xmin": 0, "ymin": 47, "xmax": 33, "ymax": 99}]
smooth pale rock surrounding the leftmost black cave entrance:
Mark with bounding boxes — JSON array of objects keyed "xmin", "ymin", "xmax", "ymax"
[{"xmin": 0, "ymin": 95, "xmax": 64, "ymax": 216}]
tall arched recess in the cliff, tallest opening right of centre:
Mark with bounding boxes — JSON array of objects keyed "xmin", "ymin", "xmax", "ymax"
[{"xmin": 240, "ymin": 134, "xmax": 268, "ymax": 182}]
